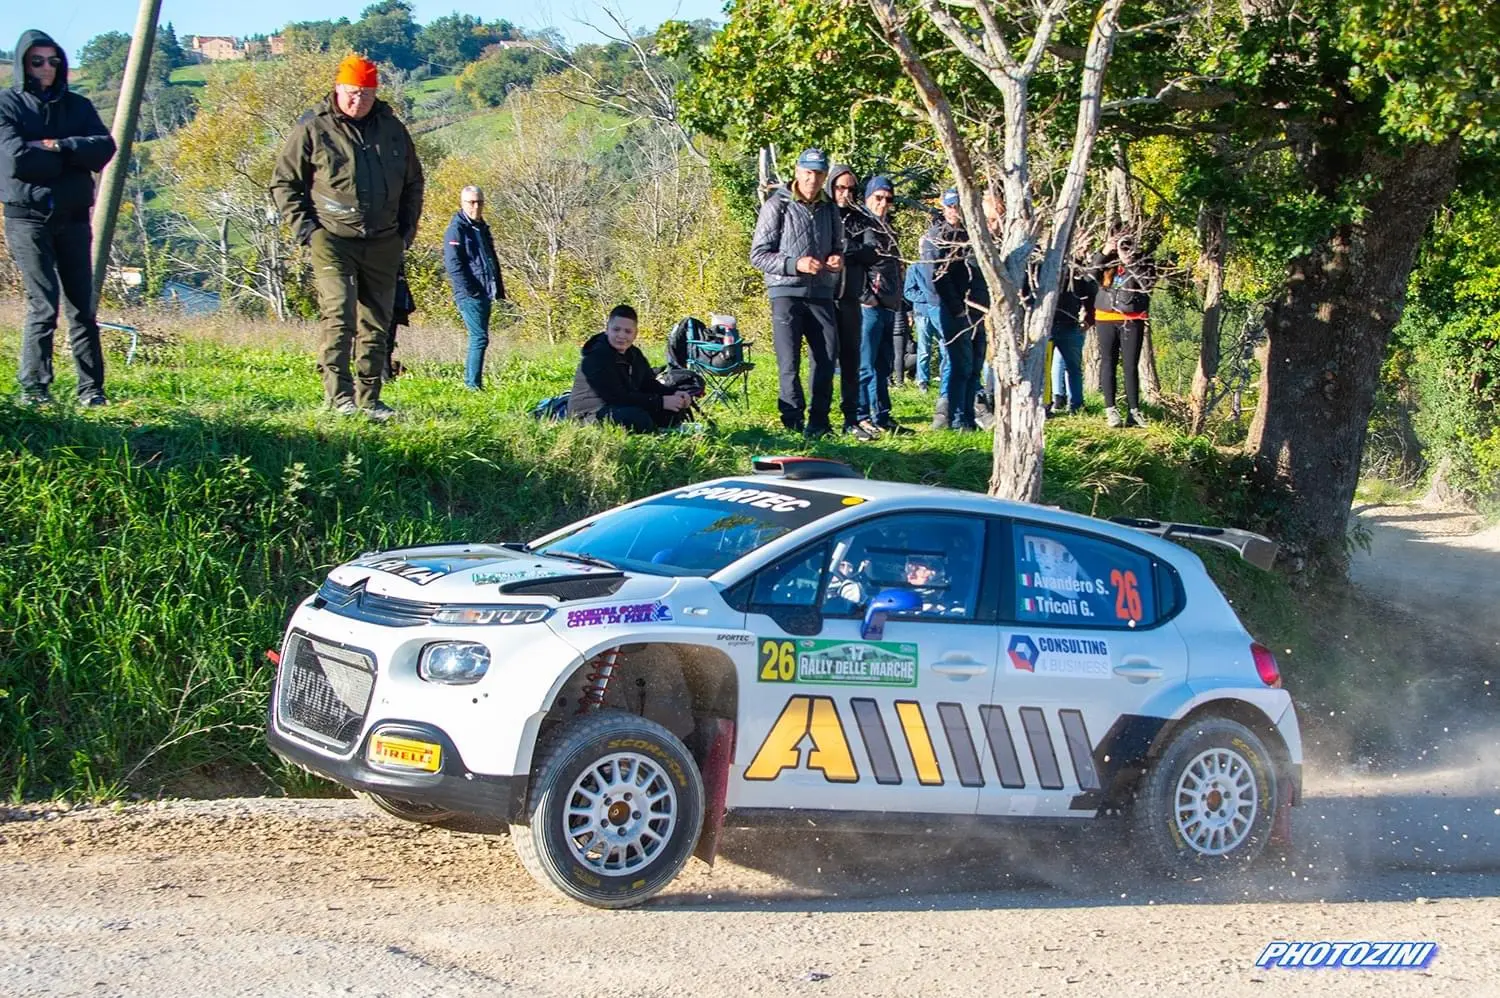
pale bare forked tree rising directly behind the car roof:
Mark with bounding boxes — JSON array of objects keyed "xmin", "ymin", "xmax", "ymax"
[{"xmin": 869, "ymin": 0, "xmax": 1139, "ymax": 501}]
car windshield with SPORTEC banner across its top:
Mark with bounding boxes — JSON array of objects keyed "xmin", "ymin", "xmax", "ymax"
[{"xmin": 531, "ymin": 480, "xmax": 864, "ymax": 576}]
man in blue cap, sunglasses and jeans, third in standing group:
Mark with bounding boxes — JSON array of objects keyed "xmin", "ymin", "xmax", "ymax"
[{"xmin": 845, "ymin": 177, "xmax": 911, "ymax": 434}]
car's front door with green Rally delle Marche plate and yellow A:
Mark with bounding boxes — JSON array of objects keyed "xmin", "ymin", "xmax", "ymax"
[{"xmin": 729, "ymin": 513, "xmax": 999, "ymax": 813}]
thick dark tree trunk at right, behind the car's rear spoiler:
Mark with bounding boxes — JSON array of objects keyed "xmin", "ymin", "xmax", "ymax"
[{"xmin": 1247, "ymin": 141, "xmax": 1460, "ymax": 572}]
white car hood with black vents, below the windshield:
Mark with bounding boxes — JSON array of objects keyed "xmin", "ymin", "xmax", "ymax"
[{"xmin": 329, "ymin": 545, "xmax": 674, "ymax": 603}]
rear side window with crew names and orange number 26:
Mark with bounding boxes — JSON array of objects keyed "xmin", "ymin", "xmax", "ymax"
[{"xmin": 1013, "ymin": 522, "xmax": 1172, "ymax": 629}]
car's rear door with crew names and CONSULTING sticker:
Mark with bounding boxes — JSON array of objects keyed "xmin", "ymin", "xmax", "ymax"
[{"xmin": 980, "ymin": 519, "xmax": 1188, "ymax": 816}]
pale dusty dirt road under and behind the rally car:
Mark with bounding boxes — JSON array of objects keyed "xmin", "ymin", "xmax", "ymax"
[{"xmin": 0, "ymin": 510, "xmax": 1500, "ymax": 998}]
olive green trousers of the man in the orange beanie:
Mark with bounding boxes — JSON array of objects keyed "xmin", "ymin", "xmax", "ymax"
[{"xmin": 311, "ymin": 228, "xmax": 407, "ymax": 407}]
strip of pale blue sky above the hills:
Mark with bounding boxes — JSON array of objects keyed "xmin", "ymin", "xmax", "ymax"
[{"xmin": 0, "ymin": 0, "xmax": 725, "ymax": 62}]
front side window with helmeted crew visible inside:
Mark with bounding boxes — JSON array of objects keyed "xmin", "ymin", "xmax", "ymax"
[{"xmin": 824, "ymin": 515, "xmax": 984, "ymax": 620}]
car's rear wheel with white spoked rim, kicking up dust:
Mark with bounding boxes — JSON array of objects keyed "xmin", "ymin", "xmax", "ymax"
[{"xmin": 1131, "ymin": 717, "xmax": 1278, "ymax": 876}]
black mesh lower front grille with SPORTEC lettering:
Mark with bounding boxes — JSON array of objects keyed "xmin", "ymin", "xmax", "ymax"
[{"xmin": 276, "ymin": 633, "xmax": 375, "ymax": 749}]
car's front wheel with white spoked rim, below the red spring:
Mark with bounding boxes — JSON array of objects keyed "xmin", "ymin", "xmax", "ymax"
[{"xmin": 510, "ymin": 710, "xmax": 704, "ymax": 908}]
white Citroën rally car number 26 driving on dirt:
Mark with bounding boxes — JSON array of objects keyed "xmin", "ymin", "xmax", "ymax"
[{"xmin": 269, "ymin": 458, "xmax": 1302, "ymax": 906}]
